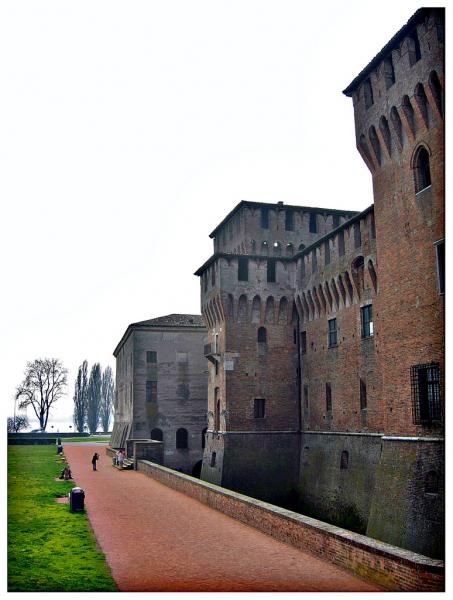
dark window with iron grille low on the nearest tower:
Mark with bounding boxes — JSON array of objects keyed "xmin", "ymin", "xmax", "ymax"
[{"xmin": 411, "ymin": 363, "xmax": 442, "ymax": 425}]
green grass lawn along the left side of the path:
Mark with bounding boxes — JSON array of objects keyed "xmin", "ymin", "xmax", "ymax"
[{"xmin": 8, "ymin": 445, "xmax": 117, "ymax": 592}]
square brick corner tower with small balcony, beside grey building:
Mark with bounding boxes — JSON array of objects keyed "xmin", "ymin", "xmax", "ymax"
[{"xmin": 196, "ymin": 201, "xmax": 356, "ymax": 502}]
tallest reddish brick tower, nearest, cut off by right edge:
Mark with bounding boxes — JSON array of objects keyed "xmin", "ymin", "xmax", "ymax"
[{"xmin": 344, "ymin": 8, "xmax": 444, "ymax": 554}]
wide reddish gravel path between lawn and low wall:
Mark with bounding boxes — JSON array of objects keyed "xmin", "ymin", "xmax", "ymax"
[{"xmin": 64, "ymin": 444, "xmax": 379, "ymax": 592}]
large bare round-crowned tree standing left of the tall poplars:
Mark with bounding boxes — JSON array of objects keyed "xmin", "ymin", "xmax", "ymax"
[{"xmin": 16, "ymin": 358, "xmax": 68, "ymax": 429}]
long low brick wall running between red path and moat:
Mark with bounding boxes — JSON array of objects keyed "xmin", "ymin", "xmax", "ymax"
[{"xmin": 137, "ymin": 460, "xmax": 444, "ymax": 592}]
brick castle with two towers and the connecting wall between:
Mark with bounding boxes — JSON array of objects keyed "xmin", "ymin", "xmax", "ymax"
[{"xmin": 196, "ymin": 8, "xmax": 444, "ymax": 557}]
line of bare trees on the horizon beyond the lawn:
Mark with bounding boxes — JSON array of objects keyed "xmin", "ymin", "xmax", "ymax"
[{"xmin": 8, "ymin": 358, "xmax": 115, "ymax": 433}]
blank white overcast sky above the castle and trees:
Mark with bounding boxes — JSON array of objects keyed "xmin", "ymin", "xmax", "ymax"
[{"xmin": 0, "ymin": 0, "xmax": 444, "ymax": 431}]
